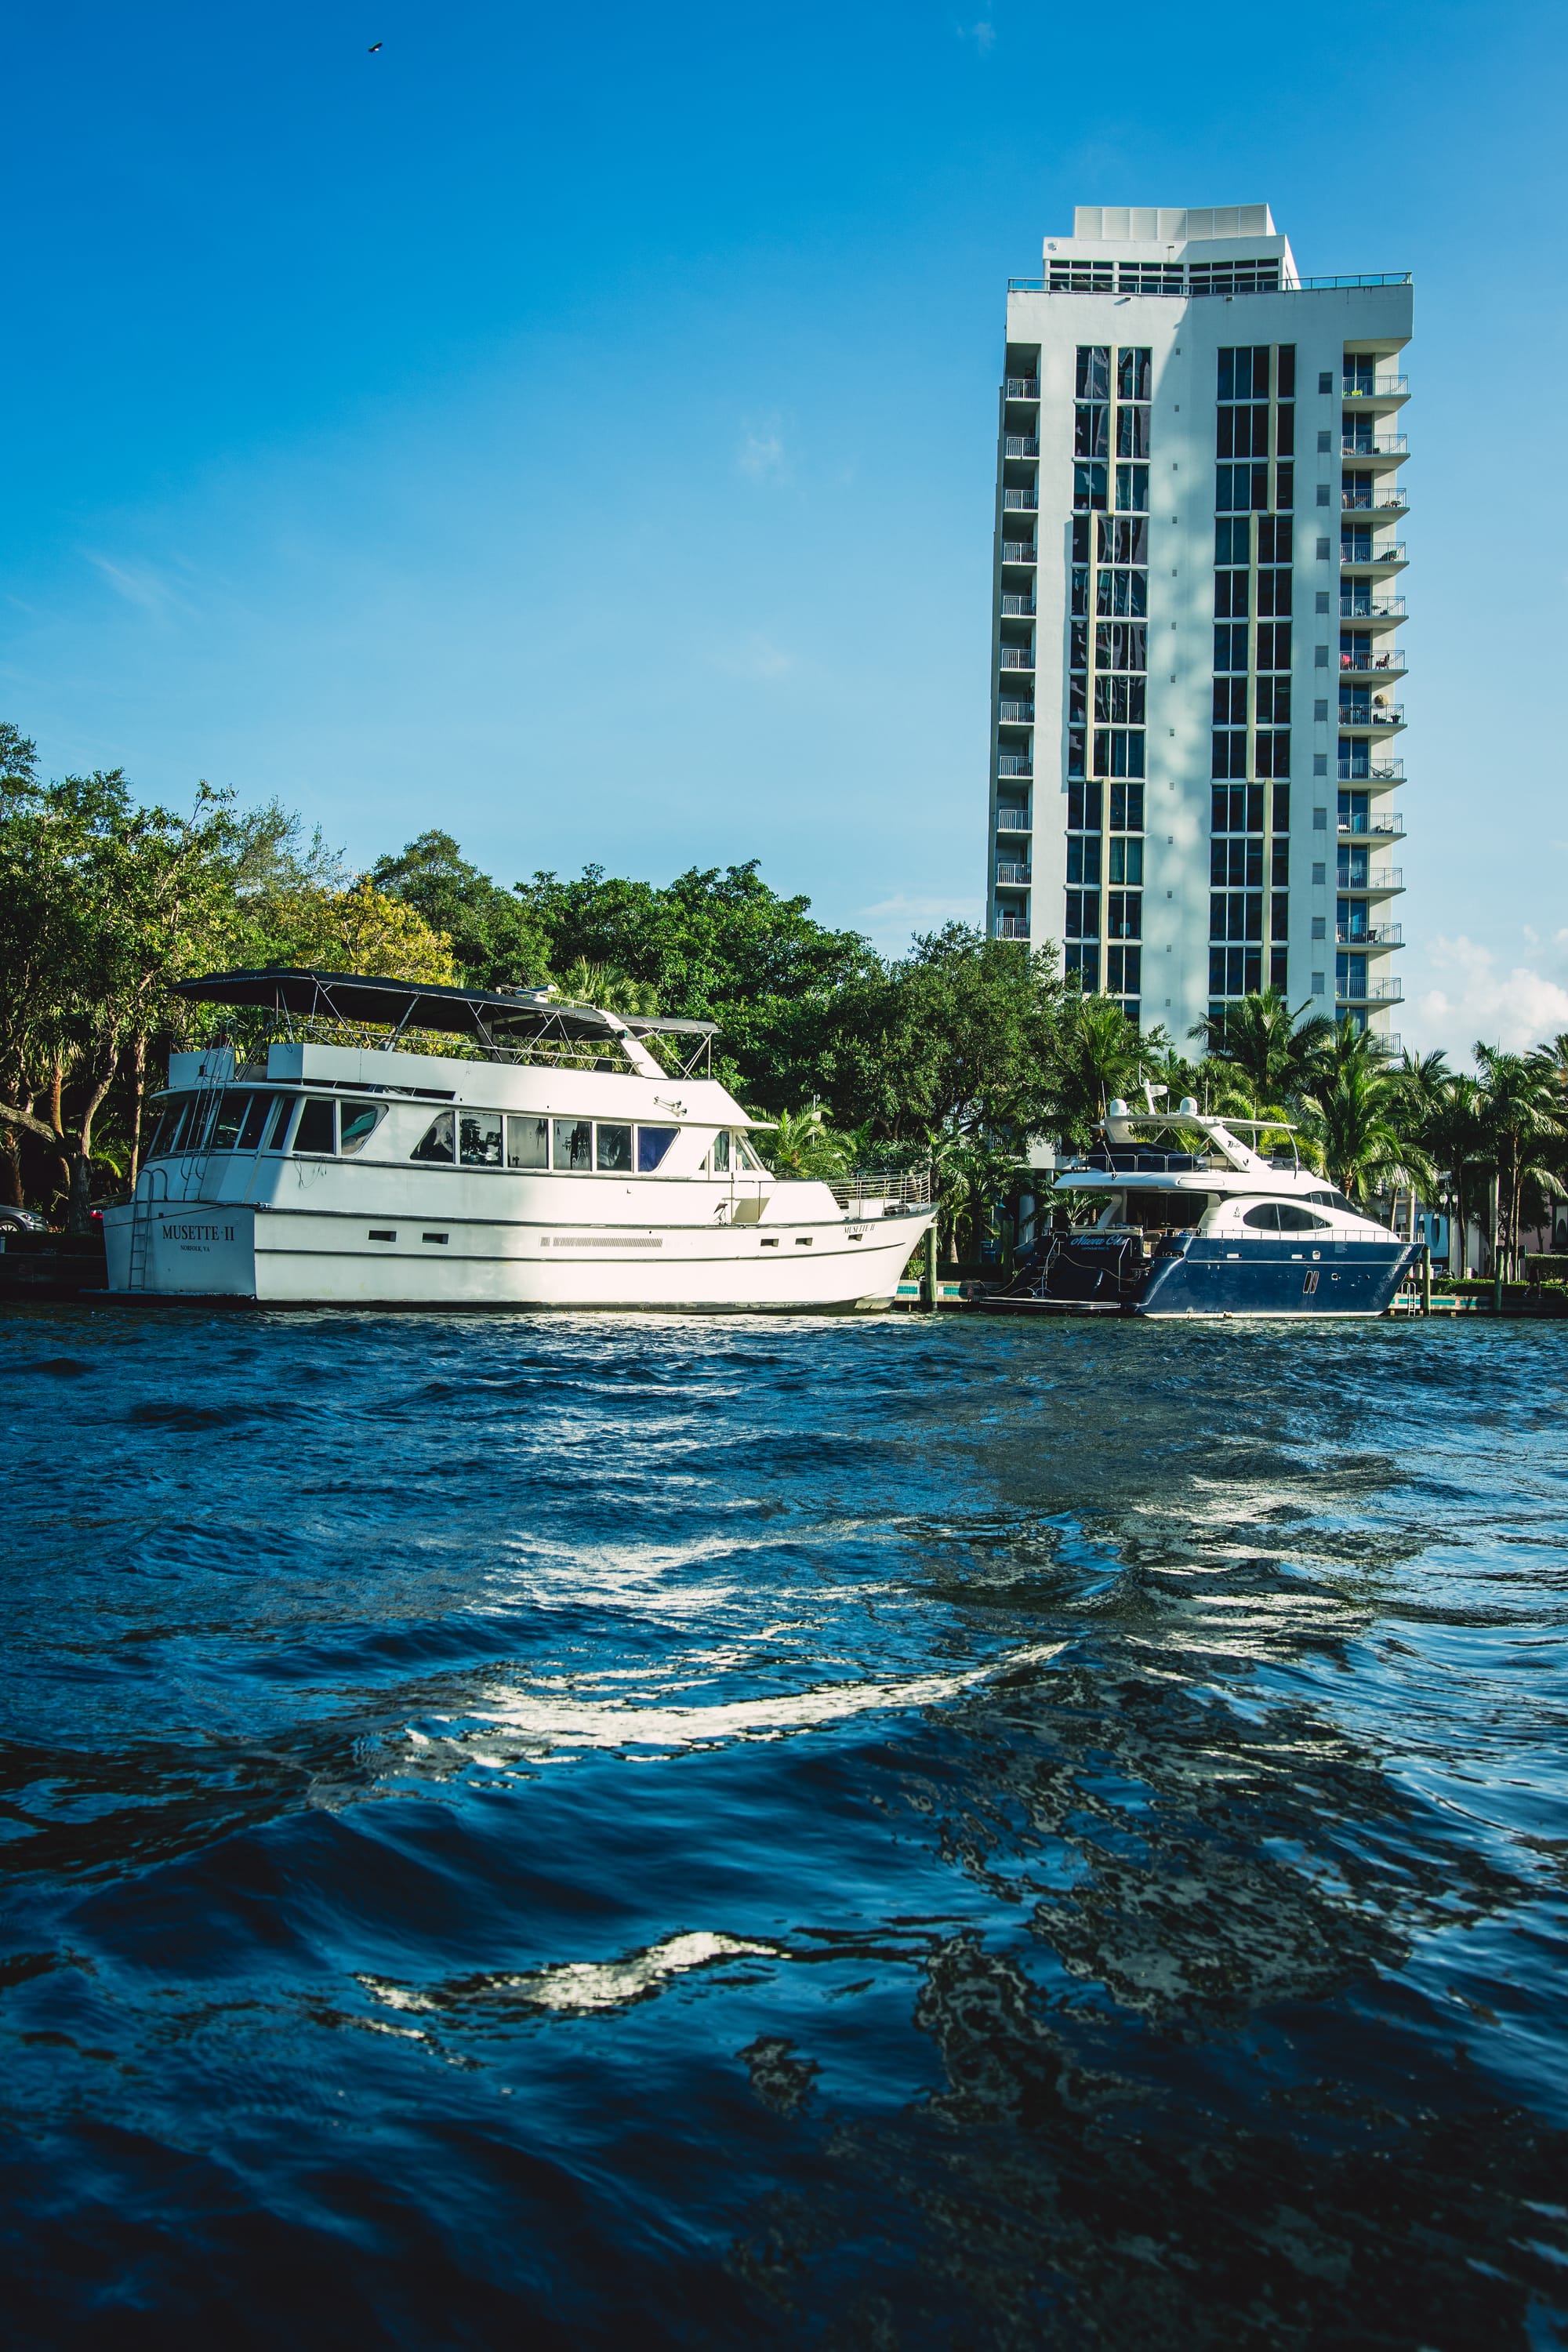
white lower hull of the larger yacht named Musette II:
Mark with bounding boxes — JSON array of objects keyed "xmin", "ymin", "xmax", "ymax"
[{"xmin": 103, "ymin": 1202, "xmax": 931, "ymax": 1312}]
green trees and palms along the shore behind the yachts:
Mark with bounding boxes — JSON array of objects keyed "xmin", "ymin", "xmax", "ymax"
[{"xmin": 0, "ymin": 722, "xmax": 1568, "ymax": 1277}]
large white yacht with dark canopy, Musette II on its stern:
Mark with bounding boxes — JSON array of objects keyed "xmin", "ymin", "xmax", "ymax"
[{"xmin": 103, "ymin": 971, "xmax": 935, "ymax": 1310}]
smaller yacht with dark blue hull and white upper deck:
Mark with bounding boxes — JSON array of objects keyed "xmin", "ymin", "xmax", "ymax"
[{"xmin": 987, "ymin": 1087, "xmax": 1420, "ymax": 1315}]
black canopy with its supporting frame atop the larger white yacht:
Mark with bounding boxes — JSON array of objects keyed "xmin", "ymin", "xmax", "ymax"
[{"xmin": 174, "ymin": 967, "xmax": 717, "ymax": 1077}]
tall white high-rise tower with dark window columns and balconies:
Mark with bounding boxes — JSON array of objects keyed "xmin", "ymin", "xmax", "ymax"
[{"xmin": 987, "ymin": 205, "xmax": 1410, "ymax": 1049}]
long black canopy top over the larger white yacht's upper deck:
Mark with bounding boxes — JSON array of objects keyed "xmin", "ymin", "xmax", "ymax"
[{"xmin": 174, "ymin": 967, "xmax": 717, "ymax": 1044}]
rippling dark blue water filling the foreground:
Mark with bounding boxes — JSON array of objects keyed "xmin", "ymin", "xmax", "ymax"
[{"xmin": 0, "ymin": 1308, "xmax": 1568, "ymax": 2352}]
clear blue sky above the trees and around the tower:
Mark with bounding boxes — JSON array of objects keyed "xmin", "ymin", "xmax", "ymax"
[{"xmin": 0, "ymin": 0, "xmax": 1568, "ymax": 1047}]
